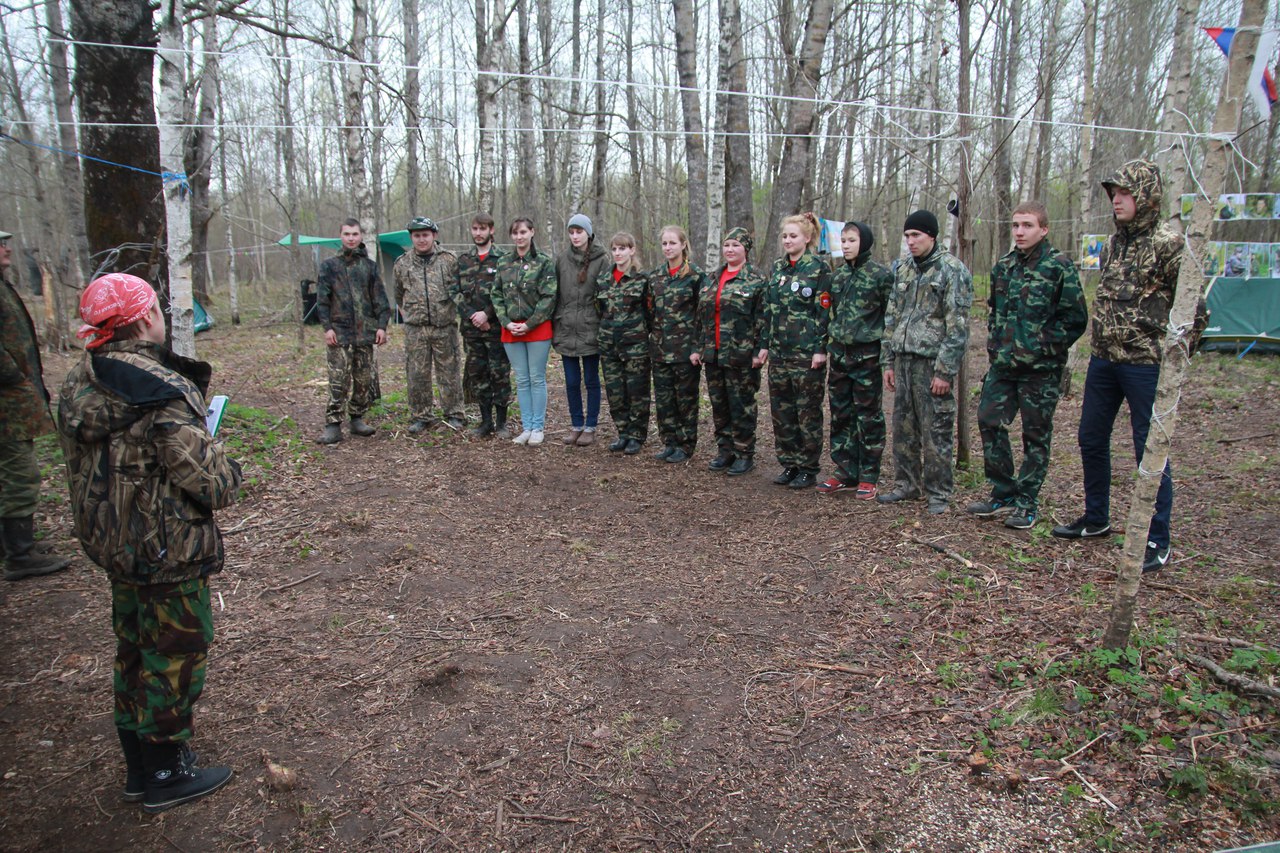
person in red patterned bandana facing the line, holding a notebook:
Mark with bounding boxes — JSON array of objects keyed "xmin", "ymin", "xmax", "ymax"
[{"xmin": 58, "ymin": 273, "xmax": 241, "ymax": 812}]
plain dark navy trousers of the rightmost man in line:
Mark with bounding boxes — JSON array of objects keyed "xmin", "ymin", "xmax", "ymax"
[{"xmin": 1078, "ymin": 356, "xmax": 1174, "ymax": 547}]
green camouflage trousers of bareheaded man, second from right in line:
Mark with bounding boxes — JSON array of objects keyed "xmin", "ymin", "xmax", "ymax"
[{"xmin": 978, "ymin": 368, "xmax": 1062, "ymax": 510}]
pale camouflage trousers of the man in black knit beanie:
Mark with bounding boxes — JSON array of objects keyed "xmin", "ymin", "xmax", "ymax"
[{"xmin": 893, "ymin": 355, "xmax": 956, "ymax": 502}]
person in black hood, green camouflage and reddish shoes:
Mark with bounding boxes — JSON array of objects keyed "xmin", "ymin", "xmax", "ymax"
[{"xmin": 818, "ymin": 222, "xmax": 893, "ymax": 501}]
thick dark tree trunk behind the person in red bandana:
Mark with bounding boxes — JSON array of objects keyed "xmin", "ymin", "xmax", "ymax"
[{"xmin": 70, "ymin": 0, "xmax": 168, "ymax": 285}]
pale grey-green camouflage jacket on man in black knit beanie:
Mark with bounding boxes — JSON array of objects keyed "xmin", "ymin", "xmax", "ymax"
[{"xmin": 881, "ymin": 245, "xmax": 973, "ymax": 382}]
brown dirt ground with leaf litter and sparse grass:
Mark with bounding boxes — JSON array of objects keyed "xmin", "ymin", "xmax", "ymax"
[{"xmin": 0, "ymin": 313, "xmax": 1280, "ymax": 852}]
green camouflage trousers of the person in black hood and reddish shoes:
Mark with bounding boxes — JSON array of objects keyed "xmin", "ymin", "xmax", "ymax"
[{"xmin": 827, "ymin": 343, "xmax": 884, "ymax": 483}]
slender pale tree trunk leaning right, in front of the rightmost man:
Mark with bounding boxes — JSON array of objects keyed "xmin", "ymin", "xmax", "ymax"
[{"xmin": 1102, "ymin": 0, "xmax": 1267, "ymax": 649}]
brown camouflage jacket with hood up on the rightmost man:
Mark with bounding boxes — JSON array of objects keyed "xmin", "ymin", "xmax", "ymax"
[{"xmin": 1092, "ymin": 160, "xmax": 1185, "ymax": 364}]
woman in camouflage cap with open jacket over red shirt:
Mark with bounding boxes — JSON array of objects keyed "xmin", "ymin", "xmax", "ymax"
[{"xmin": 695, "ymin": 228, "xmax": 768, "ymax": 476}]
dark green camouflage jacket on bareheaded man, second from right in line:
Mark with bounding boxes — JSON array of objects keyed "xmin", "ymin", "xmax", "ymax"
[{"xmin": 987, "ymin": 240, "xmax": 1089, "ymax": 373}]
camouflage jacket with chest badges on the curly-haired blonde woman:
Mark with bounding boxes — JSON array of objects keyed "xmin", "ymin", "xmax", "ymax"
[{"xmin": 763, "ymin": 251, "xmax": 831, "ymax": 365}]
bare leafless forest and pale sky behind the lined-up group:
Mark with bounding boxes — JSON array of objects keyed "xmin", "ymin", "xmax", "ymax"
[{"xmin": 0, "ymin": 0, "xmax": 1280, "ymax": 305}]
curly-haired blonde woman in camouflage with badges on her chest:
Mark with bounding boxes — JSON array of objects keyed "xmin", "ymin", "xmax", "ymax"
[{"xmin": 758, "ymin": 213, "xmax": 831, "ymax": 489}]
